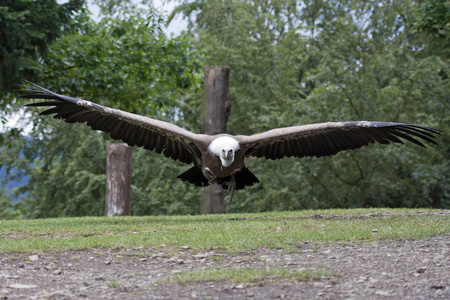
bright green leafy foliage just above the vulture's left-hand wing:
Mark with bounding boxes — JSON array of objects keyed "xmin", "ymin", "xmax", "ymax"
[{"xmin": 45, "ymin": 16, "xmax": 199, "ymax": 114}]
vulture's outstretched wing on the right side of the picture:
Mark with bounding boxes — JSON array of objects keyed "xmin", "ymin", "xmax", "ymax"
[{"xmin": 237, "ymin": 121, "xmax": 442, "ymax": 159}]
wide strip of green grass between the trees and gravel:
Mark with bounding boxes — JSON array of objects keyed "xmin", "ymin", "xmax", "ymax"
[{"xmin": 0, "ymin": 209, "xmax": 450, "ymax": 253}]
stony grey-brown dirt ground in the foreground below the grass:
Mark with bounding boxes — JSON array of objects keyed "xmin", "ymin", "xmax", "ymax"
[{"xmin": 0, "ymin": 221, "xmax": 450, "ymax": 299}]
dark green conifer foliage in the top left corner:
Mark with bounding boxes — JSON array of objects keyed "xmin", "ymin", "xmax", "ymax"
[{"xmin": 0, "ymin": 0, "xmax": 84, "ymax": 96}]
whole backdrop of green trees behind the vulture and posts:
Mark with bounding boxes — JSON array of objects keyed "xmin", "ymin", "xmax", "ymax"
[{"xmin": 0, "ymin": 0, "xmax": 450, "ymax": 219}]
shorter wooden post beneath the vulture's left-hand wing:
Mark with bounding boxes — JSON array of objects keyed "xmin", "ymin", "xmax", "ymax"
[{"xmin": 105, "ymin": 144, "xmax": 133, "ymax": 217}]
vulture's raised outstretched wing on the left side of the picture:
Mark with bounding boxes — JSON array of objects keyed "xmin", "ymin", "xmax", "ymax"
[{"xmin": 19, "ymin": 84, "xmax": 202, "ymax": 164}]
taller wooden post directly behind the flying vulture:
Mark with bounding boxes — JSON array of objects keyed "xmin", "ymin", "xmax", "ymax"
[{"xmin": 200, "ymin": 66, "xmax": 231, "ymax": 214}]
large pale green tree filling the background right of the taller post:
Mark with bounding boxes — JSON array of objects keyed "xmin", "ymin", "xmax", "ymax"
[{"xmin": 172, "ymin": 0, "xmax": 450, "ymax": 211}]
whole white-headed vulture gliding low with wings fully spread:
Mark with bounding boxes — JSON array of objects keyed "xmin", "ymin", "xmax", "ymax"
[{"xmin": 19, "ymin": 84, "xmax": 442, "ymax": 203}]
